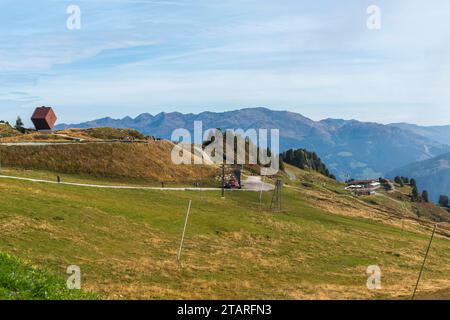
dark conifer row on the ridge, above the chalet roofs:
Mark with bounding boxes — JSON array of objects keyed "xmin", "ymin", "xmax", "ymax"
[{"xmin": 281, "ymin": 149, "xmax": 336, "ymax": 179}]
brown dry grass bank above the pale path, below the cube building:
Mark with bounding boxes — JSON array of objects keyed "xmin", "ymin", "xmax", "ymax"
[{"xmin": 0, "ymin": 141, "xmax": 219, "ymax": 184}]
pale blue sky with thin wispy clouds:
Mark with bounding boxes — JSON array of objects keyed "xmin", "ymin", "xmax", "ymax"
[{"xmin": 0, "ymin": 0, "xmax": 450, "ymax": 125}]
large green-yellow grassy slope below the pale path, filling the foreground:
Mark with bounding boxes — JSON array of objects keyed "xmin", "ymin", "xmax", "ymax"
[{"xmin": 0, "ymin": 166, "xmax": 450, "ymax": 299}]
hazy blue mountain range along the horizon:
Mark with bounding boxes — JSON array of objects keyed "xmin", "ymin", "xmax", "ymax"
[{"xmin": 56, "ymin": 108, "xmax": 450, "ymax": 180}]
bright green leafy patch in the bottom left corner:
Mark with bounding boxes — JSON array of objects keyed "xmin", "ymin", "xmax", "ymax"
[{"xmin": 0, "ymin": 253, "xmax": 98, "ymax": 300}]
